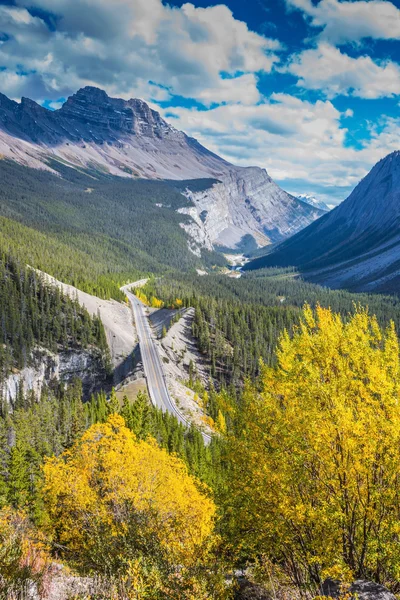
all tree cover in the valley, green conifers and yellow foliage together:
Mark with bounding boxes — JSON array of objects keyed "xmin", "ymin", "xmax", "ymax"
[{"xmin": 0, "ymin": 151, "xmax": 400, "ymax": 600}]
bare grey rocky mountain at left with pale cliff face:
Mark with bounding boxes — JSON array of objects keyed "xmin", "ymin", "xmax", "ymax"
[{"xmin": 0, "ymin": 87, "xmax": 323, "ymax": 253}]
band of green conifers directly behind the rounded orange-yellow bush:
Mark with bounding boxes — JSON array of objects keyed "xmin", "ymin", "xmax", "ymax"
[{"xmin": 0, "ymin": 379, "xmax": 221, "ymax": 519}]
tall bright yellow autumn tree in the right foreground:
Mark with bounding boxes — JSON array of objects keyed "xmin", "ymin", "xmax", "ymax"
[{"xmin": 225, "ymin": 307, "xmax": 400, "ymax": 586}]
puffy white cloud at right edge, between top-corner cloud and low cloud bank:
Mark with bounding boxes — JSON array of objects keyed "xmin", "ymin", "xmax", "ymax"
[{"xmin": 286, "ymin": 42, "xmax": 400, "ymax": 98}]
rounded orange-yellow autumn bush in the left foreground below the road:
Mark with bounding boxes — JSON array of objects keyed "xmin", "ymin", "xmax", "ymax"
[{"xmin": 43, "ymin": 415, "xmax": 225, "ymax": 599}]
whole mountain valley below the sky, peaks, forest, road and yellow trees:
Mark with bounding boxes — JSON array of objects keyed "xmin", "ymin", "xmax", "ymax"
[{"xmin": 0, "ymin": 86, "xmax": 400, "ymax": 600}]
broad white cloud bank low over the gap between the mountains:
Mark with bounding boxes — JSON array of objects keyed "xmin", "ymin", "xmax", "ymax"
[{"xmin": 164, "ymin": 94, "xmax": 400, "ymax": 202}]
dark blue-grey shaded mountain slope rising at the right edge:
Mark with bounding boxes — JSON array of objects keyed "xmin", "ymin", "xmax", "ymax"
[{"xmin": 246, "ymin": 151, "xmax": 400, "ymax": 292}]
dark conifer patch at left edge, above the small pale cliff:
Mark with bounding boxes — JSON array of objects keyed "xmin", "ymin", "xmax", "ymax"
[{"xmin": 0, "ymin": 254, "xmax": 108, "ymax": 385}]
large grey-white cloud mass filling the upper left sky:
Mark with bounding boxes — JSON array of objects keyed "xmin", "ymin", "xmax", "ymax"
[{"xmin": 0, "ymin": 0, "xmax": 280, "ymax": 104}]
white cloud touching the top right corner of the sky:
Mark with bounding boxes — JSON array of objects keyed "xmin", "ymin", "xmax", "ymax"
[{"xmin": 286, "ymin": 0, "xmax": 400, "ymax": 44}]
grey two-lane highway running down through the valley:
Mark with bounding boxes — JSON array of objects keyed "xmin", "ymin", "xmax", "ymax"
[{"xmin": 121, "ymin": 284, "xmax": 211, "ymax": 444}]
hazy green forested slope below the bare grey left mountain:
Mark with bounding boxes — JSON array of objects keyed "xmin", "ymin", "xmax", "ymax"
[{"xmin": 0, "ymin": 160, "xmax": 225, "ymax": 299}]
